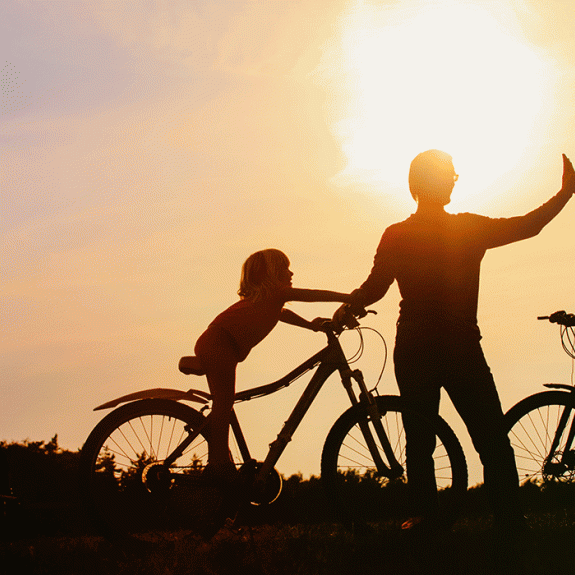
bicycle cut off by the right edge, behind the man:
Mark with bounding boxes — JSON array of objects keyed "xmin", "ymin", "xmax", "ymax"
[{"xmin": 505, "ymin": 311, "xmax": 575, "ymax": 485}]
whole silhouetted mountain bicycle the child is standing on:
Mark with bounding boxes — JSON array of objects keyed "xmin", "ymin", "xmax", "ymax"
[{"xmin": 80, "ymin": 310, "xmax": 467, "ymax": 540}]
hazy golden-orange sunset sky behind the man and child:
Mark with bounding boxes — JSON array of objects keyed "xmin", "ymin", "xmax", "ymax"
[{"xmin": 0, "ymin": 0, "xmax": 575, "ymax": 483}]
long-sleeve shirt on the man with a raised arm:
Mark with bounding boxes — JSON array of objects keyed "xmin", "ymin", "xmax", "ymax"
[{"xmin": 361, "ymin": 190, "xmax": 571, "ymax": 326}]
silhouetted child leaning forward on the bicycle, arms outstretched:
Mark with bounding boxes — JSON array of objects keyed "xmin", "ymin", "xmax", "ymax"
[{"xmin": 179, "ymin": 249, "xmax": 351, "ymax": 483}]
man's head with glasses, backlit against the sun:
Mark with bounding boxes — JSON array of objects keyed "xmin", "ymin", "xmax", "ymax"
[{"xmin": 409, "ymin": 150, "xmax": 457, "ymax": 205}]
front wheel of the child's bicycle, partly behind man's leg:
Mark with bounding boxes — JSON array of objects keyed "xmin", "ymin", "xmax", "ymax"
[{"xmin": 321, "ymin": 396, "xmax": 467, "ymax": 527}]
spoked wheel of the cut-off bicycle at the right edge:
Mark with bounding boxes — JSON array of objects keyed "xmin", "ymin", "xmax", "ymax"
[{"xmin": 505, "ymin": 391, "xmax": 575, "ymax": 485}]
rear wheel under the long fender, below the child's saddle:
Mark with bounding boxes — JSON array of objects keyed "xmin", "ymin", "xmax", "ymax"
[{"xmin": 79, "ymin": 399, "xmax": 221, "ymax": 543}]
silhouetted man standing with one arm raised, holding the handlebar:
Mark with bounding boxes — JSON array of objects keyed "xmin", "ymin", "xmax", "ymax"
[{"xmin": 353, "ymin": 150, "xmax": 575, "ymax": 531}]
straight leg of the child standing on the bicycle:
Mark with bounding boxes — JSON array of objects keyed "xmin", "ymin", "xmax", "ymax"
[{"xmin": 195, "ymin": 328, "xmax": 238, "ymax": 472}]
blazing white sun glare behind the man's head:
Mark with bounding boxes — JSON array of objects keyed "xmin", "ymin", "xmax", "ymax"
[{"xmin": 328, "ymin": 1, "xmax": 544, "ymax": 207}]
